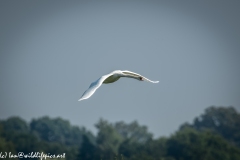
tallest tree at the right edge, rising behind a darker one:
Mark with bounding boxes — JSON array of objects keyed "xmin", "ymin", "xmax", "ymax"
[{"xmin": 182, "ymin": 106, "xmax": 240, "ymax": 147}]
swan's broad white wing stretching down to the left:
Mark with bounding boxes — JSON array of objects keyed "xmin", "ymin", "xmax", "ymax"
[{"xmin": 78, "ymin": 74, "xmax": 112, "ymax": 101}]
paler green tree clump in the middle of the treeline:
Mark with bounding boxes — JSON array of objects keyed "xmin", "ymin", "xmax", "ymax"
[{"xmin": 96, "ymin": 119, "xmax": 153, "ymax": 159}]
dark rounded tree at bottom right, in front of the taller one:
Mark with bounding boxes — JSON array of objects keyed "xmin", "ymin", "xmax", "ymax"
[{"xmin": 166, "ymin": 127, "xmax": 240, "ymax": 160}]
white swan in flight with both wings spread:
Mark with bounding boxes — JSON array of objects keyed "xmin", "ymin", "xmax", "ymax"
[{"xmin": 78, "ymin": 70, "xmax": 159, "ymax": 101}]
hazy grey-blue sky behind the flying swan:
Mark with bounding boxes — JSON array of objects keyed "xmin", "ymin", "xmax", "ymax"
[{"xmin": 0, "ymin": 0, "xmax": 240, "ymax": 137}]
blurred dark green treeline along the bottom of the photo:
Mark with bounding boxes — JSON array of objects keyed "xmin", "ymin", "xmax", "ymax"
[{"xmin": 0, "ymin": 106, "xmax": 240, "ymax": 160}]
